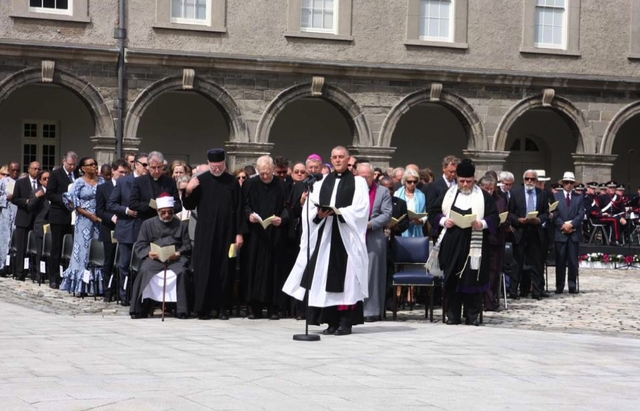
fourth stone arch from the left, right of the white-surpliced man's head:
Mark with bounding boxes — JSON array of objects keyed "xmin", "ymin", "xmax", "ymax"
[{"xmin": 377, "ymin": 89, "xmax": 489, "ymax": 150}]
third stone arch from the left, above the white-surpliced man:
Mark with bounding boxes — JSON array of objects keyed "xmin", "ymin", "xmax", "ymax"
[{"xmin": 255, "ymin": 83, "xmax": 373, "ymax": 147}]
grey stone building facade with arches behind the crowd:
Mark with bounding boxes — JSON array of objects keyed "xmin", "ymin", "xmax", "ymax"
[{"xmin": 0, "ymin": 0, "xmax": 640, "ymax": 184}]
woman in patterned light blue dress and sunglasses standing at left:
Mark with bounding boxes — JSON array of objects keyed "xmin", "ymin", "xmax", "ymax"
[{"xmin": 60, "ymin": 157, "xmax": 104, "ymax": 295}]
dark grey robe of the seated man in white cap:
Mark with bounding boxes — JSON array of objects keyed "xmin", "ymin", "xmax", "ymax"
[{"xmin": 129, "ymin": 217, "xmax": 191, "ymax": 317}]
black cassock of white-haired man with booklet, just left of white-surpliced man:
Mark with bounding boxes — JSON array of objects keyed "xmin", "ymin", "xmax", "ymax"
[{"xmin": 241, "ymin": 177, "xmax": 289, "ymax": 315}]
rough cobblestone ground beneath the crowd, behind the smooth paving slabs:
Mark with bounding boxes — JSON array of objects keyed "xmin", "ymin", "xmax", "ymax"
[{"xmin": 0, "ymin": 269, "xmax": 640, "ymax": 338}]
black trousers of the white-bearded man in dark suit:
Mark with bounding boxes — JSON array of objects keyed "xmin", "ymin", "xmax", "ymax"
[{"xmin": 509, "ymin": 228, "xmax": 544, "ymax": 296}]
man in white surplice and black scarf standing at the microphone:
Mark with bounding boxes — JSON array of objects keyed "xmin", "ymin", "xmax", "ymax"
[{"xmin": 283, "ymin": 146, "xmax": 369, "ymax": 335}]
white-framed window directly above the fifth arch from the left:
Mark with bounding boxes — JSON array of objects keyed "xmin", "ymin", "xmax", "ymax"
[{"xmin": 534, "ymin": 0, "xmax": 568, "ymax": 49}]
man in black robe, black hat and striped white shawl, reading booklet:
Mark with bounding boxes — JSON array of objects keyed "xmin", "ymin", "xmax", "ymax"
[{"xmin": 429, "ymin": 159, "xmax": 500, "ymax": 325}]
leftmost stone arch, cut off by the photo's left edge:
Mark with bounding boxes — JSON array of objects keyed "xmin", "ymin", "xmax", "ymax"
[{"xmin": 0, "ymin": 67, "xmax": 116, "ymax": 138}]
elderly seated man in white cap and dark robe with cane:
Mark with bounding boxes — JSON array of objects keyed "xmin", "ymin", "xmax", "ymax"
[{"xmin": 129, "ymin": 194, "xmax": 191, "ymax": 319}]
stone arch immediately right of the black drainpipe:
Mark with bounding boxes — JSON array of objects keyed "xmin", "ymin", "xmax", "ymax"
[{"xmin": 124, "ymin": 76, "xmax": 249, "ymax": 142}]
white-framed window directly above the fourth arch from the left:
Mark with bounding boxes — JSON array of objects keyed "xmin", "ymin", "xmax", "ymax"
[{"xmin": 419, "ymin": 0, "xmax": 454, "ymax": 41}]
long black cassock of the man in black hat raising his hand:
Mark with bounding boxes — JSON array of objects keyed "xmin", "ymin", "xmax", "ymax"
[{"xmin": 182, "ymin": 171, "xmax": 247, "ymax": 315}]
